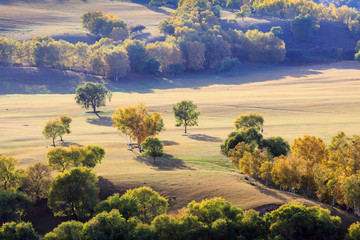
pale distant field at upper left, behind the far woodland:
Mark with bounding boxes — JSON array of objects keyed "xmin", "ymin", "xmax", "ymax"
[{"xmin": 0, "ymin": 0, "xmax": 172, "ymax": 43}]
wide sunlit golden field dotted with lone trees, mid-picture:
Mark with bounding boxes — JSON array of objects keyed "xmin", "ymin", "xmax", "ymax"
[{"xmin": 0, "ymin": 62, "xmax": 360, "ymax": 232}]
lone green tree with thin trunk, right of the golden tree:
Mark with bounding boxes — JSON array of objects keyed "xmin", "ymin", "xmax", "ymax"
[{"xmin": 173, "ymin": 100, "xmax": 200, "ymax": 133}]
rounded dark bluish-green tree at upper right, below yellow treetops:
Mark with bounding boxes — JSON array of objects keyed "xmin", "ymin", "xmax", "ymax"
[{"xmin": 291, "ymin": 14, "xmax": 313, "ymax": 41}]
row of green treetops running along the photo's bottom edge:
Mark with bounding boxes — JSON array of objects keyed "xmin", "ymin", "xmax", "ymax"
[{"xmin": 0, "ymin": 187, "xmax": 346, "ymax": 240}]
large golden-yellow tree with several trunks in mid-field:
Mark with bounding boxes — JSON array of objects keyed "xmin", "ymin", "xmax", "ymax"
[{"xmin": 112, "ymin": 103, "xmax": 164, "ymax": 152}]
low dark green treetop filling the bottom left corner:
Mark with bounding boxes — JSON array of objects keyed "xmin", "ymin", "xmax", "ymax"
[{"xmin": 0, "ymin": 222, "xmax": 40, "ymax": 240}]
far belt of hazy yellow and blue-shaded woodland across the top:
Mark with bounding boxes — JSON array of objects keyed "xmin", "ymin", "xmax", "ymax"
[{"xmin": 0, "ymin": 0, "xmax": 360, "ymax": 81}]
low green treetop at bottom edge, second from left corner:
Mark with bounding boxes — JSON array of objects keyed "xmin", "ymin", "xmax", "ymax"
[{"xmin": 43, "ymin": 220, "xmax": 84, "ymax": 240}]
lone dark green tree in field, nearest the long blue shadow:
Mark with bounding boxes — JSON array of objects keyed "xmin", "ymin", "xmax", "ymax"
[{"xmin": 75, "ymin": 83, "xmax": 112, "ymax": 113}]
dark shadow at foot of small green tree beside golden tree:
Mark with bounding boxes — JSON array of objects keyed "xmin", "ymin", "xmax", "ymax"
[{"xmin": 135, "ymin": 154, "xmax": 195, "ymax": 171}]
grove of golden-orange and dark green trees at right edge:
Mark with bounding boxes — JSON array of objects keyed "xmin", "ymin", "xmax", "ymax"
[{"xmin": 221, "ymin": 113, "xmax": 360, "ymax": 216}]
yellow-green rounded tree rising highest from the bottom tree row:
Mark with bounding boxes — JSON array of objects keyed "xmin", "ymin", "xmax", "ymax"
[{"xmin": 122, "ymin": 187, "xmax": 168, "ymax": 223}]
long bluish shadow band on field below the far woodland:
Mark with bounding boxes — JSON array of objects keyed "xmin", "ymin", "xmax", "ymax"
[{"xmin": 0, "ymin": 62, "xmax": 360, "ymax": 95}]
